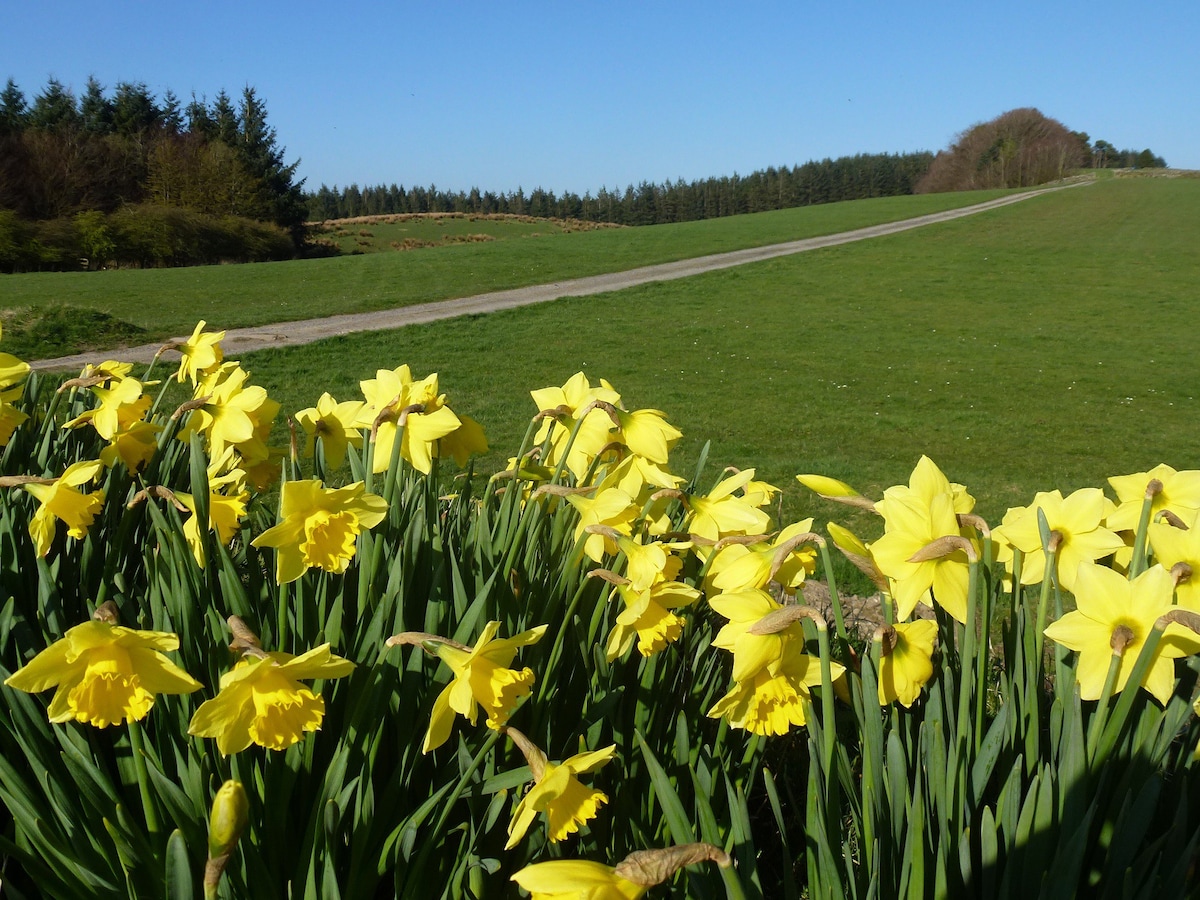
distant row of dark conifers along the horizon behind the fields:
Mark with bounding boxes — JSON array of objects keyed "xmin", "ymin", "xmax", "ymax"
[{"xmin": 306, "ymin": 151, "xmax": 934, "ymax": 226}]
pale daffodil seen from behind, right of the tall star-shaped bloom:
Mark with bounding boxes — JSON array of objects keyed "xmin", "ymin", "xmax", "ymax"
[{"xmin": 991, "ymin": 487, "xmax": 1126, "ymax": 593}]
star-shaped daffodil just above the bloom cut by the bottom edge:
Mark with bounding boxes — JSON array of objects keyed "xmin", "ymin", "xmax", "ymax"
[{"xmin": 504, "ymin": 728, "xmax": 617, "ymax": 850}]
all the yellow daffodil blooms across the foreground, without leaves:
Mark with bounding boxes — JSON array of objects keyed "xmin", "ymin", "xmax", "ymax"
[{"xmin": 7, "ymin": 322, "xmax": 1200, "ymax": 900}]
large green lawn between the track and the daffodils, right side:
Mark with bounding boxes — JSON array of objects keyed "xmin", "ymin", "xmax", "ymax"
[{"xmin": 236, "ymin": 179, "xmax": 1200, "ymax": 523}]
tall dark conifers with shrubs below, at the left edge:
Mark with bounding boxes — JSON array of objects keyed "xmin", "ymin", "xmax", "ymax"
[{"xmin": 0, "ymin": 78, "xmax": 307, "ymax": 271}]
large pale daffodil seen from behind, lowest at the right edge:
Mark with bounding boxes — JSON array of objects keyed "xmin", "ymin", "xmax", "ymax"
[{"xmin": 1045, "ymin": 562, "xmax": 1200, "ymax": 704}]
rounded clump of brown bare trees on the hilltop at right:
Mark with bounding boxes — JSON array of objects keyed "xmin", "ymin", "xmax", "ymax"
[{"xmin": 916, "ymin": 108, "xmax": 1166, "ymax": 193}]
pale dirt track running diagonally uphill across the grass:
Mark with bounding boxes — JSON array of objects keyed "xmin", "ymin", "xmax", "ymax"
[{"xmin": 30, "ymin": 180, "xmax": 1091, "ymax": 371}]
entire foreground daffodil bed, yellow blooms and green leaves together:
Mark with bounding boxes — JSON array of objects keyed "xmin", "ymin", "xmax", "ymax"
[{"xmin": 0, "ymin": 323, "xmax": 1200, "ymax": 900}]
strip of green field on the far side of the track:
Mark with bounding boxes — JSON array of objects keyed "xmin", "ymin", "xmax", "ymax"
[{"xmin": 0, "ymin": 191, "xmax": 1007, "ymax": 358}]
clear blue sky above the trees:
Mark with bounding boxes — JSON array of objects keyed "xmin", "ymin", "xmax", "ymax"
[{"xmin": 0, "ymin": 0, "xmax": 1200, "ymax": 194}]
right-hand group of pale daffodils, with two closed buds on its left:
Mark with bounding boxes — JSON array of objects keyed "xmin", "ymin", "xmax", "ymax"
[{"xmin": 798, "ymin": 457, "xmax": 1200, "ymax": 712}]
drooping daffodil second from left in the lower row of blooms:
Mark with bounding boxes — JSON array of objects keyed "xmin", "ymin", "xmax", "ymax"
[{"xmin": 187, "ymin": 643, "xmax": 354, "ymax": 756}]
